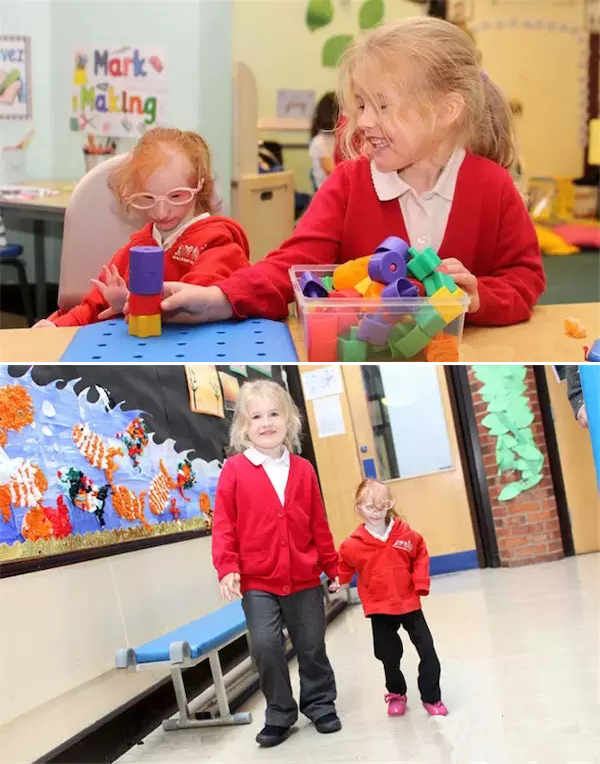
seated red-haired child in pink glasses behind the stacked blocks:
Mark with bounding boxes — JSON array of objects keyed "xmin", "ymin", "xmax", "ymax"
[{"xmin": 36, "ymin": 128, "xmax": 249, "ymax": 327}]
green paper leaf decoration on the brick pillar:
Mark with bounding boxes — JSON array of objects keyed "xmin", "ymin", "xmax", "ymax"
[{"xmin": 473, "ymin": 365, "xmax": 544, "ymax": 501}]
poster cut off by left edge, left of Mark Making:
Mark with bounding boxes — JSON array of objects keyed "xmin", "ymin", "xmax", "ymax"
[{"xmin": 0, "ymin": 35, "xmax": 31, "ymax": 119}]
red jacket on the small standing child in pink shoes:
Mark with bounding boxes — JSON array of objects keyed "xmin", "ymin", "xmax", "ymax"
[{"xmin": 339, "ymin": 519, "xmax": 429, "ymax": 615}]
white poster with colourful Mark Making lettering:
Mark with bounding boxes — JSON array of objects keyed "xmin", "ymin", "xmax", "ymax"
[{"xmin": 70, "ymin": 45, "xmax": 168, "ymax": 138}]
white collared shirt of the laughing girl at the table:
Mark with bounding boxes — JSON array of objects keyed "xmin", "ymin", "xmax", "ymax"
[{"xmin": 371, "ymin": 148, "xmax": 466, "ymax": 252}]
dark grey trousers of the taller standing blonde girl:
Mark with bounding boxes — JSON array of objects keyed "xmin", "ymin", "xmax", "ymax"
[{"xmin": 242, "ymin": 586, "xmax": 337, "ymax": 727}]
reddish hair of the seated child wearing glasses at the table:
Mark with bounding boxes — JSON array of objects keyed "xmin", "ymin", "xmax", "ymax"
[{"xmin": 108, "ymin": 127, "xmax": 213, "ymax": 215}]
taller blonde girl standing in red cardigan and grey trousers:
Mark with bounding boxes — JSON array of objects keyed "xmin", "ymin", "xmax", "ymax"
[{"xmin": 212, "ymin": 380, "xmax": 342, "ymax": 747}]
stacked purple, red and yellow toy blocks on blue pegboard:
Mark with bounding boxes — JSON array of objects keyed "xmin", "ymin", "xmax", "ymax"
[{"xmin": 129, "ymin": 247, "xmax": 165, "ymax": 337}]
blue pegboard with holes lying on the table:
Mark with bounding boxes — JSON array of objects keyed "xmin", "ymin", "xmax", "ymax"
[{"xmin": 60, "ymin": 318, "xmax": 298, "ymax": 363}]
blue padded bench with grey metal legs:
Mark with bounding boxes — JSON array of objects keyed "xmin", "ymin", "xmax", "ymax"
[{"xmin": 115, "ymin": 600, "xmax": 252, "ymax": 730}]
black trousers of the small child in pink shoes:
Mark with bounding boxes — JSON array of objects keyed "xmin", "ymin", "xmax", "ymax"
[{"xmin": 370, "ymin": 610, "xmax": 441, "ymax": 703}]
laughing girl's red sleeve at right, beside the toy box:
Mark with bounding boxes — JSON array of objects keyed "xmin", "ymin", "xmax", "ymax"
[{"xmin": 466, "ymin": 174, "xmax": 546, "ymax": 326}]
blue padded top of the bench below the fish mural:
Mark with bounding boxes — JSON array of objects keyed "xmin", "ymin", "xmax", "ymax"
[{"xmin": 135, "ymin": 600, "xmax": 247, "ymax": 663}]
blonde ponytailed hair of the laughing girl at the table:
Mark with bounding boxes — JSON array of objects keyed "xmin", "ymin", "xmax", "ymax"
[{"xmin": 338, "ymin": 17, "xmax": 516, "ymax": 168}]
